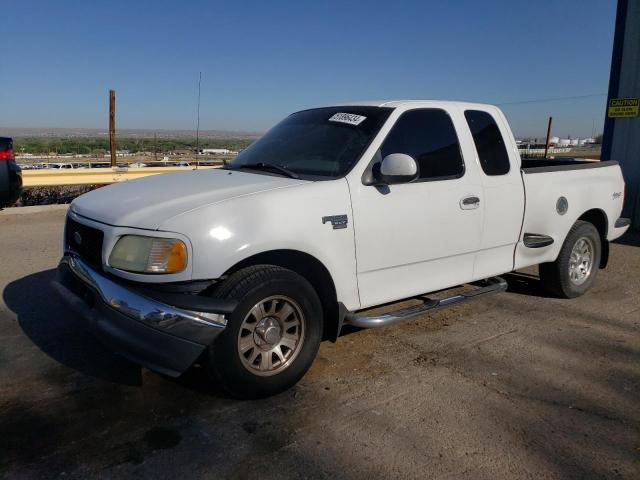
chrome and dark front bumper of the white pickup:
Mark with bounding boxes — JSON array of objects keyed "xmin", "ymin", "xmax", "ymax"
[{"xmin": 53, "ymin": 253, "xmax": 235, "ymax": 376}]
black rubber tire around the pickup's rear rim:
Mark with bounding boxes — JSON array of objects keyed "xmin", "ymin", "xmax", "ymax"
[{"xmin": 539, "ymin": 220, "xmax": 602, "ymax": 298}]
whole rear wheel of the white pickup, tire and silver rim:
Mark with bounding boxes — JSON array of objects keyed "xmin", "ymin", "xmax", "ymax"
[{"xmin": 539, "ymin": 220, "xmax": 602, "ymax": 298}]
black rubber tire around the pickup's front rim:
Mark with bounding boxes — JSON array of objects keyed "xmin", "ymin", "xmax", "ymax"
[{"xmin": 201, "ymin": 265, "xmax": 323, "ymax": 399}]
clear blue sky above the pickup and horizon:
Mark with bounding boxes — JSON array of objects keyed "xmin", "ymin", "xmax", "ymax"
[{"xmin": 0, "ymin": 0, "xmax": 615, "ymax": 136}]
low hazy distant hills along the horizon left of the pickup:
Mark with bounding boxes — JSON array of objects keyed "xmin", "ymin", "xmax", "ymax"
[{"xmin": 0, "ymin": 127, "xmax": 262, "ymax": 139}]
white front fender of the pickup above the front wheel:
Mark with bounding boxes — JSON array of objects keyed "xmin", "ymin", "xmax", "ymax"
[{"xmin": 160, "ymin": 179, "xmax": 360, "ymax": 309}]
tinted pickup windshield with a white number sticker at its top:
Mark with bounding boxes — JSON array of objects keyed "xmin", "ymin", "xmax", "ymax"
[{"xmin": 226, "ymin": 106, "xmax": 392, "ymax": 179}]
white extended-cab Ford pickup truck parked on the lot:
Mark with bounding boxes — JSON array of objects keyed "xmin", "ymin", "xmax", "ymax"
[{"xmin": 54, "ymin": 101, "xmax": 629, "ymax": 398}]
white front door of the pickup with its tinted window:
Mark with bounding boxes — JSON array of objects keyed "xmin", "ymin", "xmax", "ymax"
[{"xmin": 349, "ymin": 108, "xmax": 483, "ymax": 308}]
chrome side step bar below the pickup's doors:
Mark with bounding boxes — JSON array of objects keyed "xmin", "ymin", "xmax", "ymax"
[{"xmin": 344, "ymin": 277, "xmax": 507, "ymax": 328}]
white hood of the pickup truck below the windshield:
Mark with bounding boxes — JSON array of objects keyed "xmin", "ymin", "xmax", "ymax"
[{"xmin": 71, "ymin": 169, "xmax": 306, "ymax": 230}]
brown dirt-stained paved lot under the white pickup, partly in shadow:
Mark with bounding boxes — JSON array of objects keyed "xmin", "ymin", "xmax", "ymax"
[{"xmin": 0, "ymin": 210, "xmax": 640, "ymax": 480}]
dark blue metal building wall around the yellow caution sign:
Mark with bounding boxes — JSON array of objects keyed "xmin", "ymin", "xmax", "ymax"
[{"xmin": 602, "ymin": 0, "xmax": 640, "ymax": 229}]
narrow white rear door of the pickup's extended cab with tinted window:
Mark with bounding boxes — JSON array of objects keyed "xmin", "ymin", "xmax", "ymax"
[{"xmin": 464, "ymin": 107, "xmax": 524, "ymax": 280}]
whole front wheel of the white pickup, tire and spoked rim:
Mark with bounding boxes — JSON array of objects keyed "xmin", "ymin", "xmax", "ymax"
[{"xmin": 201, "ymin": 265, "xmax": 323, "ymax": 398}]
